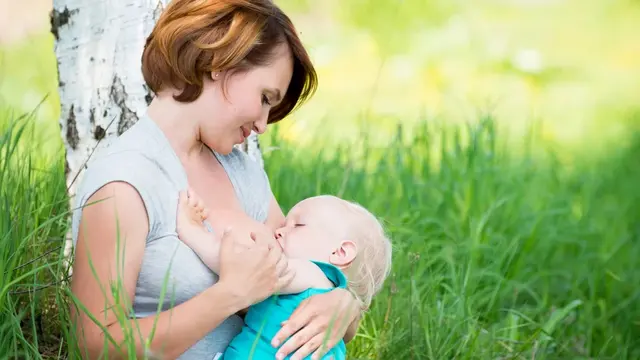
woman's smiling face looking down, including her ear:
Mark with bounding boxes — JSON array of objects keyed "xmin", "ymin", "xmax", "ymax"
[{"xmin": 192, "ymin": 44, "xmax": 293, "ymax": 154}]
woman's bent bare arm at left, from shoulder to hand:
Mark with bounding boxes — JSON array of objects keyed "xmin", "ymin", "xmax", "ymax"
[{"xmin": 71, "ymin": 182, "xmax": 290, "ymax": 359}]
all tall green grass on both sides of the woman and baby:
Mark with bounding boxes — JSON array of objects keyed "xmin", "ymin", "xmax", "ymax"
[{"xmin": 0, "ymin": 103, "xmax": 640, "ymax": 359}]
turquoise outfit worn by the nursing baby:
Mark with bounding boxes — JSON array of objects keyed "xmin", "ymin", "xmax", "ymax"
[{"xmin": 223, "ymin": 261, "xmax": 347, "ymax": 360}]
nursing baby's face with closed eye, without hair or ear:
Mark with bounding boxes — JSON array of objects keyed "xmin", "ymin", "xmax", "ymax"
[{"xmin": 276, "ymin": 197, "xmax": 356, "ymax": 262}]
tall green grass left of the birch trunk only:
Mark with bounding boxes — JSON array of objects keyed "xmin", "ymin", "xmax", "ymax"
[{"xmin": 0, "ymin": 105, "xmax": 67, "ymax": 358}]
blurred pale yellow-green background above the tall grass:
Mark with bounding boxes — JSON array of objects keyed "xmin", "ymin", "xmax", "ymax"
[{"xmin": 0, "ymin": 0, "xmax": 640, "ymax": 155}]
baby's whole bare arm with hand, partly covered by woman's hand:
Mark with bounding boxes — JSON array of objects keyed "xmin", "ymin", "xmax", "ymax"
[{"xmin": 177, "ymin": 191, "xmax": 333, "ymax": 294}]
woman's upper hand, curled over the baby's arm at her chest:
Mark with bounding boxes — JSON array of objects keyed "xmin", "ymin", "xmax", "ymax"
[{"xmin": 219, "ymin": 226, "xmax": 295, "ymax": 307}]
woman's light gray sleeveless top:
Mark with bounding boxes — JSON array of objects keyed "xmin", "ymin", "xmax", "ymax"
[{"xmin": 72, "ymin": 114, "xmax": 271, "ymax": 360}]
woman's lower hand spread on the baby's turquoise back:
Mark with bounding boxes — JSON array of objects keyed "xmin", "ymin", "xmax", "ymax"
[{"xmin": 271, "ymin": 289, "xmax": 360, "ymax": 360}]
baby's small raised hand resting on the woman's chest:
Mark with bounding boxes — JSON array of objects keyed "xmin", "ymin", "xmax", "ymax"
[{"xmin": 176, "ymin": 189, "xmax": 211, "ymax": 244}]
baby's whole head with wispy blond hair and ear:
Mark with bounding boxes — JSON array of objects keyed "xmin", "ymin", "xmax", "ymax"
[{"xmin": 276, "ymin": 195, "xmax": 391, "ymax": 307}]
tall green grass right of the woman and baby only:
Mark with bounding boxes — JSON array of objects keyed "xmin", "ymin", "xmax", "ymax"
[{"xmin": 267, "ymin": 119, "xmax": 640, "ymax": 359}]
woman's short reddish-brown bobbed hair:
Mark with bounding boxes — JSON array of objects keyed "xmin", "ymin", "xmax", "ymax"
[{"xmin": 142, "ymin": 0, "xmax": 318, "ymax": 123}]
